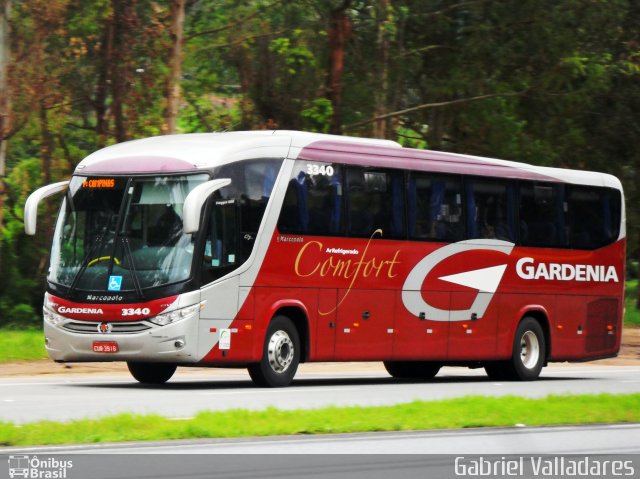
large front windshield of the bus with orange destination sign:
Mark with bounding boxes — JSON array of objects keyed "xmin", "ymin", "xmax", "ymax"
[{"xmin": 48, "ymin": 174, "xmax": 209, "ymax": 295}]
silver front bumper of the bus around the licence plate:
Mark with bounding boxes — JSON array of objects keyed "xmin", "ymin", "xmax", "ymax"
[{"xmin": 44, "ymin": 315, "xmax": 198, "ymax": 364}]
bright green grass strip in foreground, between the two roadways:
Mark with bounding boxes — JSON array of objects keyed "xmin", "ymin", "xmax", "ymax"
[{"xmin": 0, "ymin": 394, "xmax": 640, "ymax": 446}]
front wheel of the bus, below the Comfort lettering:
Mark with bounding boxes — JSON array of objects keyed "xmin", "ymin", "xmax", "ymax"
[{"xmin": 248, "ymin": 315, "xmax": 300, "ymax": 388}]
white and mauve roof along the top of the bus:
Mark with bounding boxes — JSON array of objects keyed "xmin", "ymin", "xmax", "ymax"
[{"xmin": 75, "ymin": 130, "xmax": 622, "ymax": 189}]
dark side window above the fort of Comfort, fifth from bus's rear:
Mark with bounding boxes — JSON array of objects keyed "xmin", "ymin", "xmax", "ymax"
[{"xmin": 347, "ymin": 166, "xmax": 405, "ymax": 238}]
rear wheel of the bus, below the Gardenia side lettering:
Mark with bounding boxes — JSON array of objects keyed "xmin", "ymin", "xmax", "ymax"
[{"xmin": 504, "ymin": 316, "xmax": 547, "ymax": 381}]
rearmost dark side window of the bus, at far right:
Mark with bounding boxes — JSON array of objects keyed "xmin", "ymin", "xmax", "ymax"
[{"xmin": 567, "ymin": 186, "xmax": 621, "ymax": 249}]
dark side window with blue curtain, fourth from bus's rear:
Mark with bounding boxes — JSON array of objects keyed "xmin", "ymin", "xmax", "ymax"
[{"xmin": 407, "ymin": 173, "xmax": 464, "ymax": 242}]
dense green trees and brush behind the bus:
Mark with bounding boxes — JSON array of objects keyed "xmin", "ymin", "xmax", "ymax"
[{"xmin": 0, "ymin": 0, "xmax": 640, "ymax": 325}]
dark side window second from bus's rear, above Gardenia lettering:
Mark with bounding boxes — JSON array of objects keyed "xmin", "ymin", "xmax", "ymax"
[{"xmin": 519, "ymin": 182, "xmax": 567, "ymax": 248}]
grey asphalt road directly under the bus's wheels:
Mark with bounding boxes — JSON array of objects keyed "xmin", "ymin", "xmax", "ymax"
[{"xmin": 0, "ymin": 364, "xmax": 640, "ymax": 422}]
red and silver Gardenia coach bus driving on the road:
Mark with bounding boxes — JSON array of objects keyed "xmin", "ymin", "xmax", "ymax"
[{"xmin": 25, "ymin": 131, "xmax": 626, "ymax": 387}]
